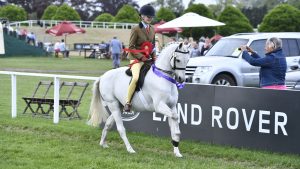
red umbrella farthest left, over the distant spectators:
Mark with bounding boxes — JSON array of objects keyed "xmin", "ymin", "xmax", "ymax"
[{"xmin": 46, "ymin": 21, "xmax": 85, "ymax": 43}]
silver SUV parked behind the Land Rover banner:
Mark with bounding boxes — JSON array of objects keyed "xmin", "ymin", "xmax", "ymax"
[{"xmin": 186, "ymin": 32, "xmax": 300, "ymax": 87}]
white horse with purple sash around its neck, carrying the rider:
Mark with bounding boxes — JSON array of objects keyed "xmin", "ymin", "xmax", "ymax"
[{"xmin": 89, "ymin": 44, "xmax": 190, "ymax": 157}]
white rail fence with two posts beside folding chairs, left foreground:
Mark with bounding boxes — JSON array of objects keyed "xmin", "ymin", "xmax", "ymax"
[{"xmin": 0, "ymin": 71, "xmax": 99, "ymax": 124}]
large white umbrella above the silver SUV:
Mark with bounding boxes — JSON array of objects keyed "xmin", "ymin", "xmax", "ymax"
[{"xmin": 158, "ymin": 12, "xmax": 225, "ymax": 28}]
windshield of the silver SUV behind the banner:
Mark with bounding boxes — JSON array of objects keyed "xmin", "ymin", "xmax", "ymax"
[{"xmin": 205, "ymin": 38, "xmax": 248, "ymax": 56}]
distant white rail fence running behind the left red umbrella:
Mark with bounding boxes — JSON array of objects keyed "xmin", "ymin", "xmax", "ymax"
[{"xmin": 9, "ymin": 20, "xmax": 137, "ymax": 29}]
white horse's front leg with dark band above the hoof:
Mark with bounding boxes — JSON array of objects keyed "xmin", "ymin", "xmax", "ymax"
[{"xmin": 155, "ymin": 102, "xmax": 182, "ymax": 157}]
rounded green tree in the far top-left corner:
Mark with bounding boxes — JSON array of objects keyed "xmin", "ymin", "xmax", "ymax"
[{"xmin": 0, "ymin": 5, "xmax": 27, "ymax": 21}]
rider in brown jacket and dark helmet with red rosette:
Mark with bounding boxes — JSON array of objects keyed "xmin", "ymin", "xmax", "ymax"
[{"xmin": 124, "ymin": 4, "xmax": 155, "ymax": 112}]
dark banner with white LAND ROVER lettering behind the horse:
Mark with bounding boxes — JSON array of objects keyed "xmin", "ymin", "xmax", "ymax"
[{"xmin": 124, "ymin": 84, "xmax": 300, "ymax": 154}]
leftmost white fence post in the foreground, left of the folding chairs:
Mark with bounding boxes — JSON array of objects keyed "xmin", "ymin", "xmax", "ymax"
[{"xmin": 11, "ymin": 74, "xmax": 17, "ymax": 118}]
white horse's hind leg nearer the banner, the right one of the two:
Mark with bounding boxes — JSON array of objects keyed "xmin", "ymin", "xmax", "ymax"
[{"xmin": 108, "ymin": 102, "xmax": 135, "ymax": 153}]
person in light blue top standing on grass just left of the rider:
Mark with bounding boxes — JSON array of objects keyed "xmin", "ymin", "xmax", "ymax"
[{"xmin": 109, "ymin": 36, "xmax": 122, "ymax": 69}]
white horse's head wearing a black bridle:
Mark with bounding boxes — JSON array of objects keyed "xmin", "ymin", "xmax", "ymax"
[{"xmin": 170, "ymin": 43, "xmax": 190, "ymax": 83}]
